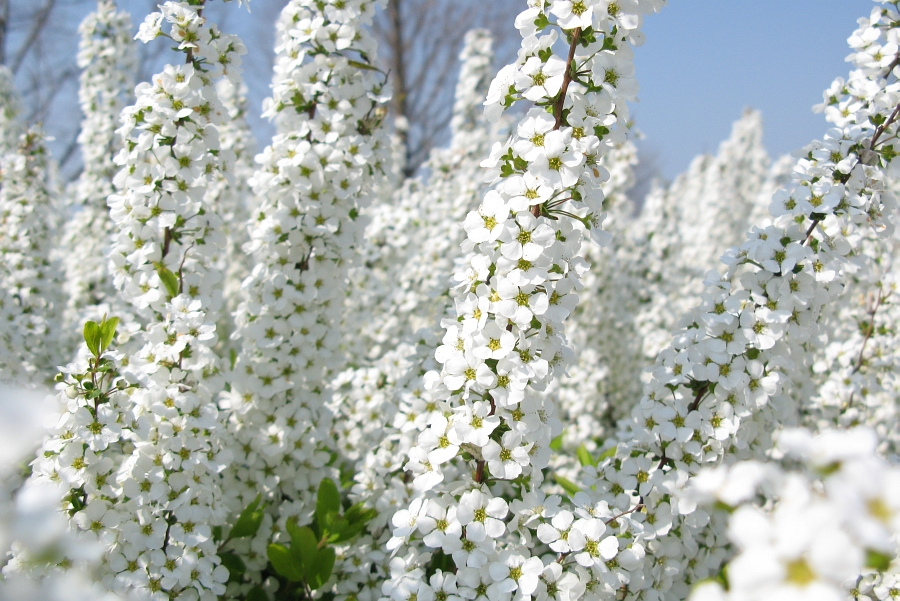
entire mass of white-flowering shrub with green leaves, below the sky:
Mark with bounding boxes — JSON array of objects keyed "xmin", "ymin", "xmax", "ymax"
[{"xmin": 0, "ymin": 0, "xmax": 900, "ymax": 601}]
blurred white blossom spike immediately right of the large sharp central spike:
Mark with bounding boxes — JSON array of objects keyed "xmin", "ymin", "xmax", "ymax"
[{"xmin": 545, "ymin": 136, "xmax": 647, "ymax": 450}]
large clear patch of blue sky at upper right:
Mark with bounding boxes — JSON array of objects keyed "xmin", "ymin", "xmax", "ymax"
[{"xmin": 631, "ymin": 0, "xmax": 875, "ymax": 179}]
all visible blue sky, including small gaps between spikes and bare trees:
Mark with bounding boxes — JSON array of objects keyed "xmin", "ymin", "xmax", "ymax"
[{"xmin": 12, "ymin": 0, "xmax": 876, "ymax": 179}]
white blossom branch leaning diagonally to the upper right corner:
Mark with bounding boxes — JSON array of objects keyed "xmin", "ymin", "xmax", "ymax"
[{"xmin": 560, "ymin": 5, "xmax": 900, "ymax": 598}]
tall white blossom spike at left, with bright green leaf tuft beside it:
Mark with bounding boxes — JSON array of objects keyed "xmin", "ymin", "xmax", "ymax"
[{"xmin": 17, "ymin": 2, "xmax": 244, "ymax": 599}]
